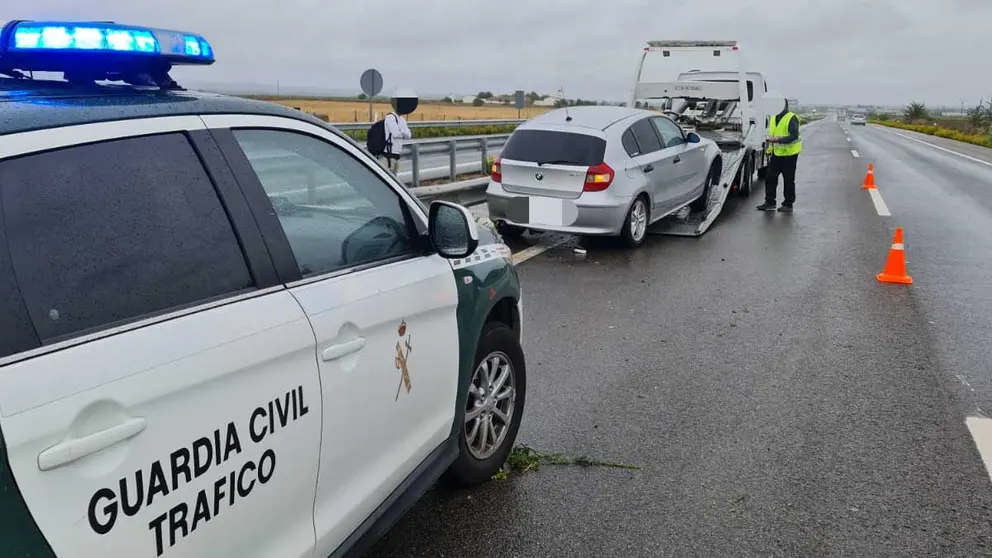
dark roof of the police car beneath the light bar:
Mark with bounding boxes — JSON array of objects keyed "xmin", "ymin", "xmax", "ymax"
[{"xmin": 0, "ymin": 77, "xmax": 343, "ymax": 136}]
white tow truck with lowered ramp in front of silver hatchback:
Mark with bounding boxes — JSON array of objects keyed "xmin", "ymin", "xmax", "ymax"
[{"xmin": 629, "ymin": 40, "xmax": 768, "ymax": 236}]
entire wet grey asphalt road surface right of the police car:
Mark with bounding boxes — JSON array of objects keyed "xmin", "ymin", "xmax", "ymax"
[{"xmin": 368, "ymin": 117, "xmax": 992, "ymax": 557}]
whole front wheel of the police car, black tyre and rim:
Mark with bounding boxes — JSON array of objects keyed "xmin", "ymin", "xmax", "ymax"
[{"xmin": 446, "ymin": 322, "xmax": 527, "ymax": 486}]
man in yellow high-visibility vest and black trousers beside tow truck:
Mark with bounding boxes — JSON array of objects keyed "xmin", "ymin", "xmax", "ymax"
[{"xmin": 758, "ymin": 99, "xmax": 803, "ymax": 212}]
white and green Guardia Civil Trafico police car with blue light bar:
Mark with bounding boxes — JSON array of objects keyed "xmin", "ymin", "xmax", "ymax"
[{"xmin": 0, "ymin": 21, "xmax": 526, "ymax": 558}]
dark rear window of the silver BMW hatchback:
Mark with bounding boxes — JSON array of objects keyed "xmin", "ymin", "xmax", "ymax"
[{"xmin": 500, "ymin": 130, "xmax": 606, "ymax": 167}]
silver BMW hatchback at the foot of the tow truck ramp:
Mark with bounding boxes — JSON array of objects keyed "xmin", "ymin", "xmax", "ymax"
[{"xmin": 486, "ymin": 106, "xmax": 721, "ymax": 247}]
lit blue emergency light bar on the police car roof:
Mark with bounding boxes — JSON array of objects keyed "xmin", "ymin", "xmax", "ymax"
[{"xmin": 0, "ymin": 21, "xmax": 214, "ymax": 66}]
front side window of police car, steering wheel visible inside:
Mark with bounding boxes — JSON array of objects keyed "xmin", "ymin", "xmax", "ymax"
[{"xmin": 234, "ymin": 129, "xmax": 419, "ymax": 277}]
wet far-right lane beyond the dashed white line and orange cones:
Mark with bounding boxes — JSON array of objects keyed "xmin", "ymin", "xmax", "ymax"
[{"xmin": 850, "ymin": 126, "xmax": 992, "ymax": 415}]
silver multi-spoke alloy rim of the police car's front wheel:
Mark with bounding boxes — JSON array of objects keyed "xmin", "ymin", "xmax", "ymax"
[{"xmin": 464, "ymin": 351, "xmax": 517, "ymax": 461}]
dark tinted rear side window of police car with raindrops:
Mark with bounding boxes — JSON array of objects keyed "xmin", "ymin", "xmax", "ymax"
[{"xmin": 0, "ymin": 134, "xmax": 252, "ymax": 342}]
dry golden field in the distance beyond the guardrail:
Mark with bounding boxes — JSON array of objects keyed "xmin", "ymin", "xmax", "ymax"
[{"xmin": 268, "ymin": 98, "xmax": 551, "ymax": 122}]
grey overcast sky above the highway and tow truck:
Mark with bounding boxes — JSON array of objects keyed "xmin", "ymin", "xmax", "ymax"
[{"xmin": 9, "ymin": 0, "xmax": 992, "ymax": 106}]
